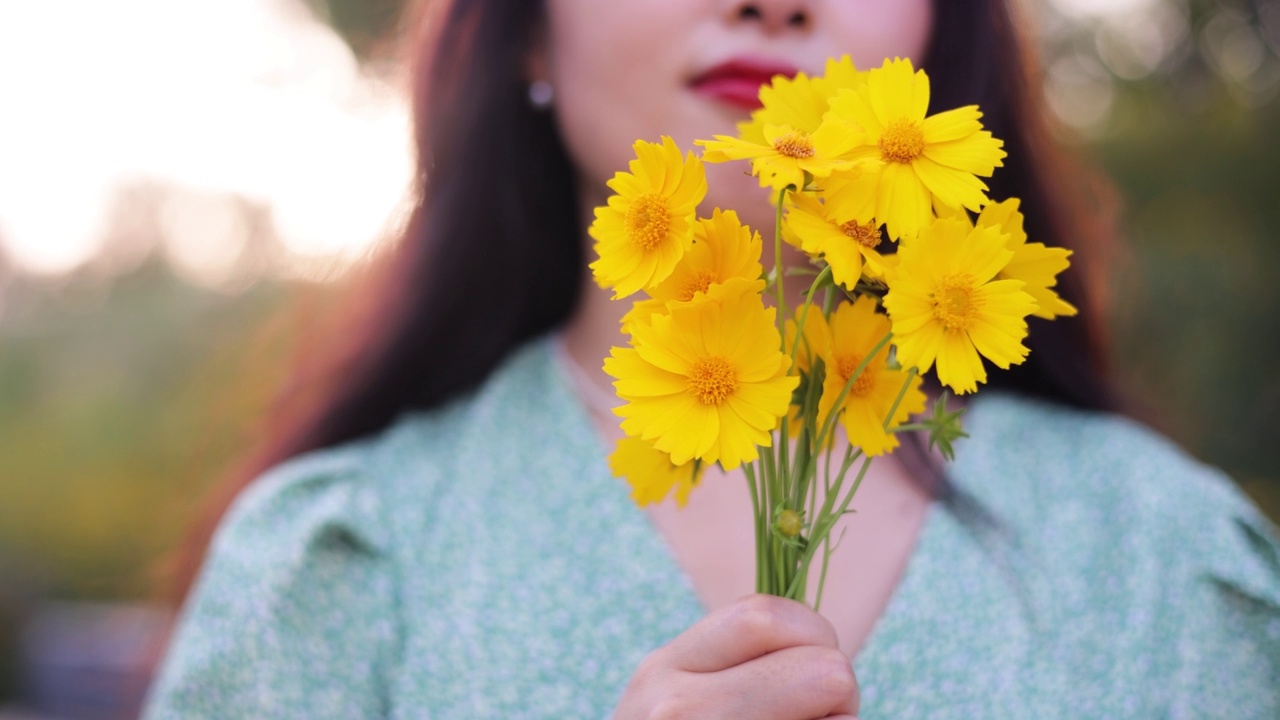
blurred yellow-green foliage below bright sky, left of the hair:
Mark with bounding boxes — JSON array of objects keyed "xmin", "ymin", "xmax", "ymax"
[{"xmin": 0, "ymin": 260, "xmax": 296, "ymax": 598}]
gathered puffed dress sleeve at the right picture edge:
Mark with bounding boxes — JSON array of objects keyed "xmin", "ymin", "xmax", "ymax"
[{"xmin": 1170, "ymin": 471, "xmax": 1280, "ymax": 720}]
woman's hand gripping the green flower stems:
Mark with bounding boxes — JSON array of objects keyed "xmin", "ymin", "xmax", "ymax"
[{"xmin": 613, "ymin": 594, "xmax": 858, "ymax": 720}]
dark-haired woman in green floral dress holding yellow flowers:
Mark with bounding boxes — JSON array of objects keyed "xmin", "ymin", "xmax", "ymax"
[{"xmin": 142, "ymin": 0, "xmax": 1280, "ymax": 719}]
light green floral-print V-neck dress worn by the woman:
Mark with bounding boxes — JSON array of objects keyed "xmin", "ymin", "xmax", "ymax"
[{"xmin": 146, "ymin": 340, "xmax": 1280, "ymax": 720}]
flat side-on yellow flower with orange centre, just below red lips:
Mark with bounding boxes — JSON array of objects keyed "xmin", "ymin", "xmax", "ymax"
[{"xmin": 695, "ymin": 118, "xmax": 863, "ymax": 192}]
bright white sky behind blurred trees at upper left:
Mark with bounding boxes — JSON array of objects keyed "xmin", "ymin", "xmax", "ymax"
[{"xmin": 0, "ymin": 0, "xmax": 412, "ymax": 281}]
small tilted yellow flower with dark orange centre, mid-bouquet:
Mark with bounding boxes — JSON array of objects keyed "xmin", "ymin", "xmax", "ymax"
[{"xmin": 782, "ymin": 192, "xmax": 884, "ymax": 290}]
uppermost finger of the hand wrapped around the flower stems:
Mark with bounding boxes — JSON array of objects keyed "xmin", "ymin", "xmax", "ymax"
[{"xmin": 662, "ymin": 594, "xmax": 847, "ymax": 671}]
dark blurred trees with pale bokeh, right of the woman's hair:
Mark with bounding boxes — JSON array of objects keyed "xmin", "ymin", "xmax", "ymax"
[{"xmin": 1038, "ymin": 0, "xmax": 1280, "ymax": 519}]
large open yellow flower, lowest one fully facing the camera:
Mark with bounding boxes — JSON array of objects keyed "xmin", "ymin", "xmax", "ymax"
[{"xmin": 604, "ymin": 278, "xmax": 799, "ymax": 470}]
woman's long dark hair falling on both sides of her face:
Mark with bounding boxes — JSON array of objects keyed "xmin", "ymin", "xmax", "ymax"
[{"xmin": 177, "ymin": 0, "xmax": 1115, "ymax": 597}]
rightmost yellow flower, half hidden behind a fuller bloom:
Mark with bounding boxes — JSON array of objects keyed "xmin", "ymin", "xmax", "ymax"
[{"xmin": 978, "ymin": 197, "xmax": 1076, "ymax": 320}]
